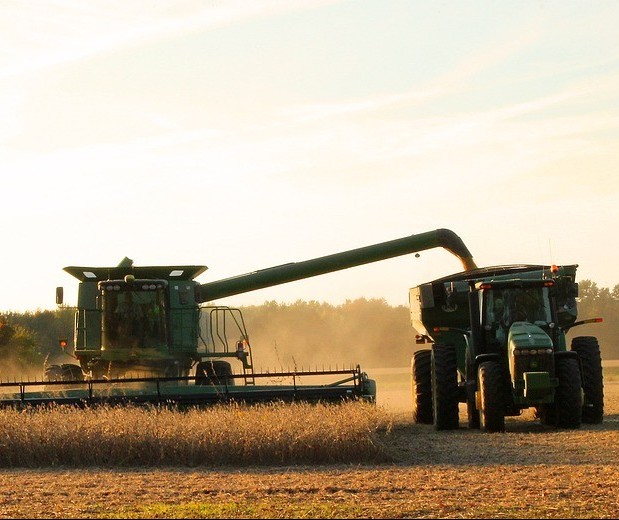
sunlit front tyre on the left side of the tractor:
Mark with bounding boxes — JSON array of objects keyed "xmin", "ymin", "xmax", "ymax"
[{"xmin": 477, "ymin": 361, "xmax": 505, "ymax": 433}]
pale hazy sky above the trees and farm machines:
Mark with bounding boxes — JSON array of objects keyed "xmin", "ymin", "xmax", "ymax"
[{"xmin": 0, "ymin": 0, "xmax": 619, "ymax": 311}]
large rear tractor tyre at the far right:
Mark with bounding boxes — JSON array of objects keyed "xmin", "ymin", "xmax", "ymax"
[{"xmin": 572, "ymin": 336, "xmax": 604, "ymax": 424}]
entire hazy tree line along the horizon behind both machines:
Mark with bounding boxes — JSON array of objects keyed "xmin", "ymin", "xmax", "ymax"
[{"xmin": 0, "ymin": 280, "xmax": 619, "ymax": 379}]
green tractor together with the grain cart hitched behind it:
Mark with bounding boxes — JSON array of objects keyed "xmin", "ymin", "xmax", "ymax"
[{"xmin": 409, "ymin": 265, "xmax": 604, "ymax": 432}]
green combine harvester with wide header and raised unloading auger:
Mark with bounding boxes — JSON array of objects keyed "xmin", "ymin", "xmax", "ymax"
[{"xmin": 0, "ymin": 229, "xmax": 476, "ymax": 405}]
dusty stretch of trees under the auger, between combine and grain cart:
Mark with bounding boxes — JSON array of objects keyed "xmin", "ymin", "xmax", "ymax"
[{"xmin": 242, "ymin": 298, "xmax": 415, "ymax": 369}]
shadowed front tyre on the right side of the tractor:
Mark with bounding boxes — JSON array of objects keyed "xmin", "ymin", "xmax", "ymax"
[{"xmin": 553, "ymin": 357, "xmax": 582, "ymax": 429}]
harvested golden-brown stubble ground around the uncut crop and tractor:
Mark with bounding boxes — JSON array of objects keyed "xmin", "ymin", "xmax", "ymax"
[{"xmin": 0, "ymin": 363, "xmax": 619, "ymax": 518}]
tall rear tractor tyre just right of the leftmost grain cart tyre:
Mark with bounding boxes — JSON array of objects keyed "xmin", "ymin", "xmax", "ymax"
[{"xmin": 431, "ymin": 344, "xmax": 460, "ymax": 430}]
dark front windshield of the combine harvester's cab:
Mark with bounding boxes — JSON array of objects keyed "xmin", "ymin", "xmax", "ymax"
[{"xmin": 102, "ymin": 288, "xmax": 167, "ymax": 348}]
